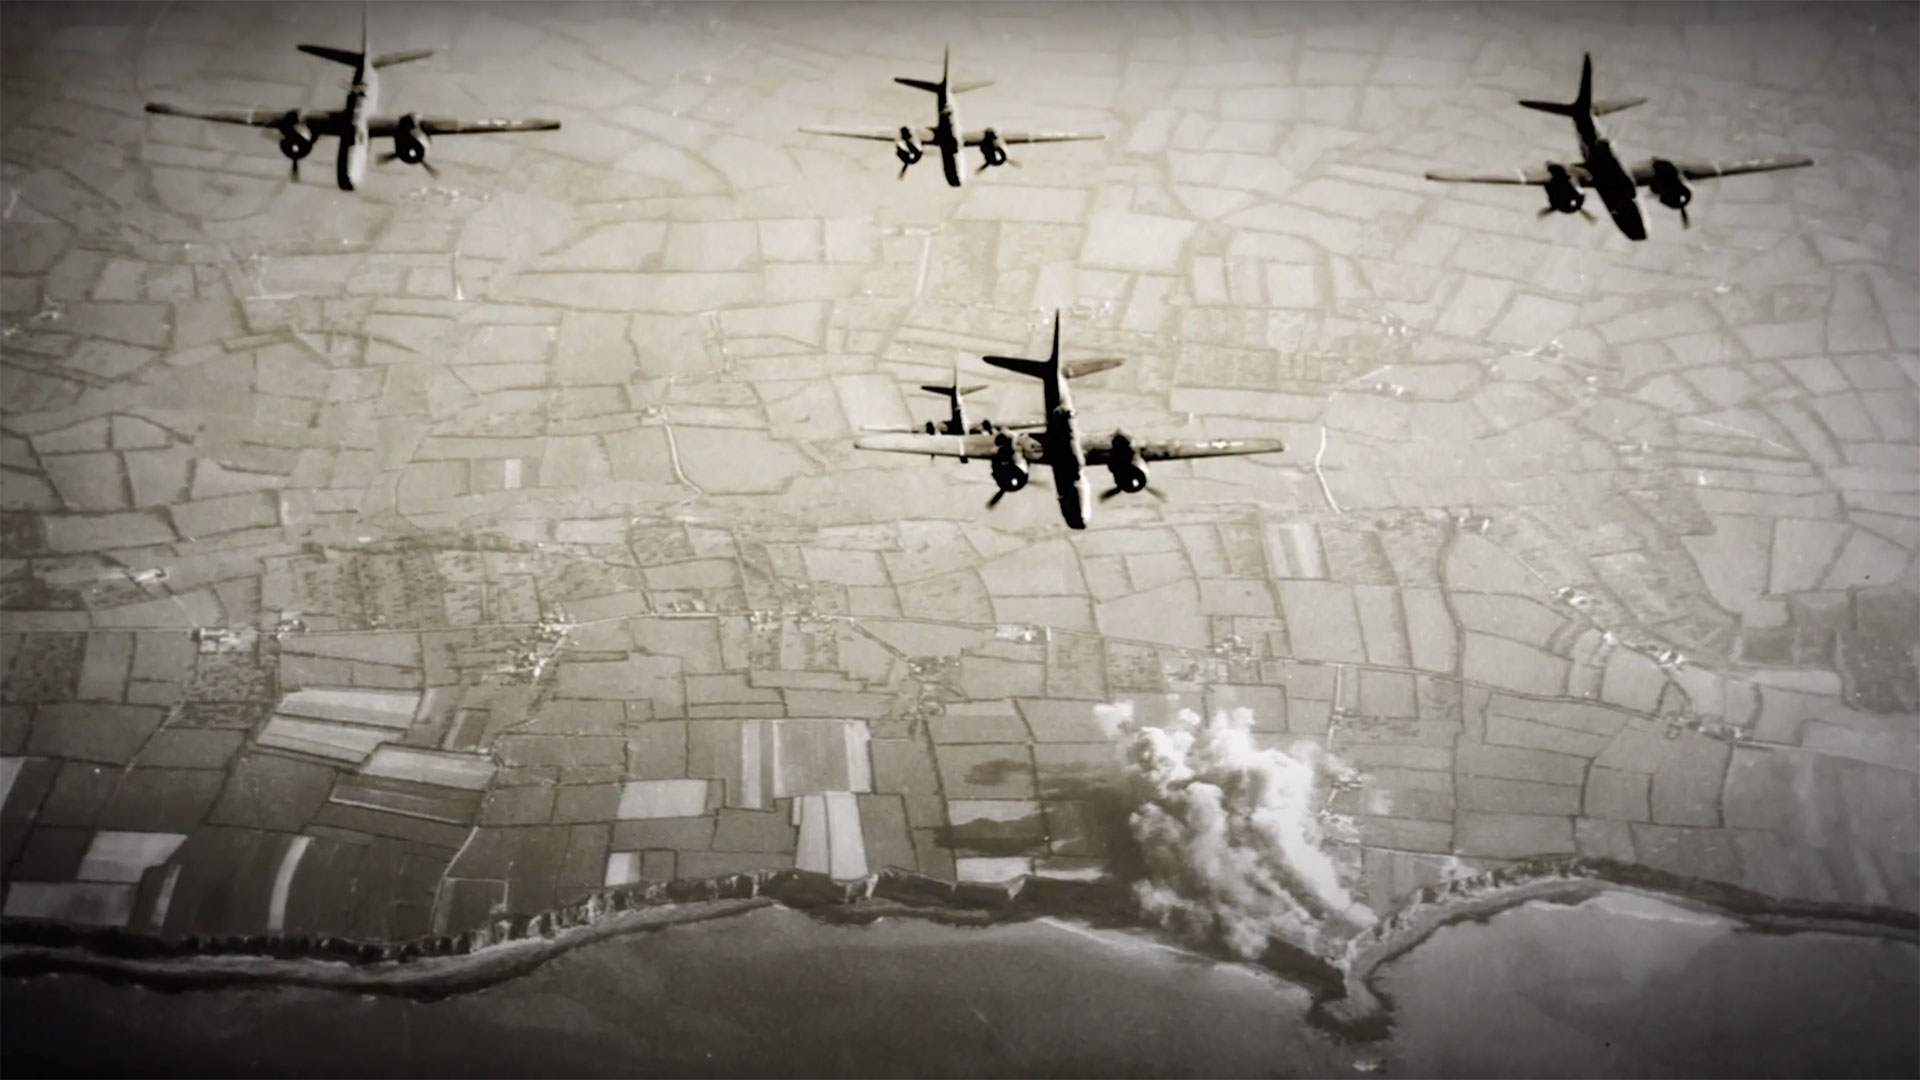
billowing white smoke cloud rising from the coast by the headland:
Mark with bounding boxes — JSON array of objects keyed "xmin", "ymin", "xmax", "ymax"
[{"xmin": 1094, "ymin": 703, "xmax": 1375, "ymax": 959}]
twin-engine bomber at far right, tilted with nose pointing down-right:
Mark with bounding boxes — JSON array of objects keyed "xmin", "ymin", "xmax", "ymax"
[{"xmin": 1427, "ymin": 54, "xmax": 1812, "ymax": 240}]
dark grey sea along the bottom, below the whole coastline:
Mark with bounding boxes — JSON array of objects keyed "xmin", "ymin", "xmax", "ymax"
[{"xmin": 0, "ymin": 894, "xmax": 1920, "ymax": 1076}]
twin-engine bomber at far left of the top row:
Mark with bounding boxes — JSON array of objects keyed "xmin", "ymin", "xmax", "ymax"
[{"xmin": 146, "ymin": 8, "xmax": 561, "ymax": 192}]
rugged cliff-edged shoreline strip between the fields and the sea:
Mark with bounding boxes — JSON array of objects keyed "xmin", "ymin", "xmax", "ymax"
[{"xmin": 0, "ymin": 859, "xmax": 1920, "ymax": 1042}]
